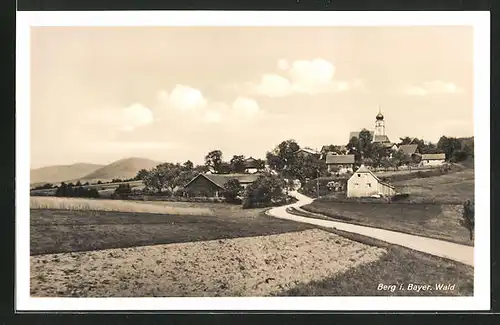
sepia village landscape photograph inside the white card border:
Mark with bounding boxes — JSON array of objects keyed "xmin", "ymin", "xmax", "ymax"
[{"xmin": 18, "ymin": 10, "xmax": 489, "ymax": 308}]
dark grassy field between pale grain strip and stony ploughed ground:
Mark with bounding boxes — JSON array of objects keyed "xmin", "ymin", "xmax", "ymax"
[{"xmin": 30, "ymin": 203, "xmax": 313, "ymax": 255}]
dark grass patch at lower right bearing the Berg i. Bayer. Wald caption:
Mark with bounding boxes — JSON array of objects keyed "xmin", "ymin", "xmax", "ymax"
[{"xmin": 281, "ymin": 224, "xmax": 474, "ymax": 296}]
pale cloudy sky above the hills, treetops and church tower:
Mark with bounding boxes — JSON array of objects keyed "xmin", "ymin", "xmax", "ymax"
[{"xmin": 30, "ymin": 26, "xmax": 474, "ymax": 168}]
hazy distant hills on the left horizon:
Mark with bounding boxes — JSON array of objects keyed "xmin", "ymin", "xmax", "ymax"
[{"xmin": 30, "ymin": 157, "xmax": 160, "ymax": 185}]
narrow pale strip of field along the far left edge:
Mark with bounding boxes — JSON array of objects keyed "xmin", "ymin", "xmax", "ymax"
[{"xmin": 30, "ymin": 196, "xmax": 212, "ymax": 216}]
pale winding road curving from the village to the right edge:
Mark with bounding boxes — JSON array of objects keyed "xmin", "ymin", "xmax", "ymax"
[{"xmin": 266, "ymin": 191, "xmax": 474, "ymax": 266}]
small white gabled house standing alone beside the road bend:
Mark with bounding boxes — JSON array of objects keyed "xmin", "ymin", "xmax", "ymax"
[{"xmin": 347, "ymin": 165, "xmax": 396, "ymax": 197}]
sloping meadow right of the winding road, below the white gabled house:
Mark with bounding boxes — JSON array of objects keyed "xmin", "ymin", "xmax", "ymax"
[{"xmin": 302, "ymin": 169, "xmax": 474, "ymax": 246}]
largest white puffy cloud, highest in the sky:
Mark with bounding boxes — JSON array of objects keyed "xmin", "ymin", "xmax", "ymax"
[{"xmin": 250, "ymin": 59, "xmax": 361, "ymax": 97}]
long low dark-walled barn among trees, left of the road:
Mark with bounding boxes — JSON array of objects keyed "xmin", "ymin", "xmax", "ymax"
[{"xmin": 184, "ymin": 174, "xmax": 260, "ymax": 197}]
